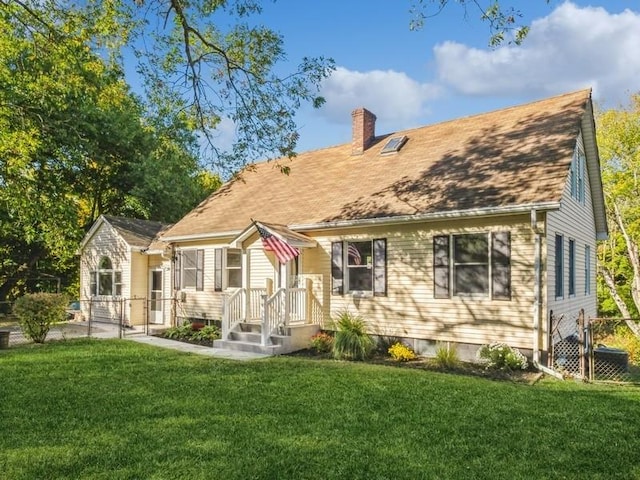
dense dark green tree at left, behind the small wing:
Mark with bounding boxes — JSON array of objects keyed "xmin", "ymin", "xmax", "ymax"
[{"xmin": 0, "ymin": 1, "xmax": 215, "ymax": 300}]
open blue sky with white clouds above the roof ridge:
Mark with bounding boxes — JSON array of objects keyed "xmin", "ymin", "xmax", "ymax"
[{"xmin": 224, "ymin": 0, "xmax": 640, "ymax": 151}]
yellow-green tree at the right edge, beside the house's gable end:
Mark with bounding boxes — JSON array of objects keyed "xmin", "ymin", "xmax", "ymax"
[{"xmin": 597, "ymin": 94, "xmax": 640, "ymax": 330}]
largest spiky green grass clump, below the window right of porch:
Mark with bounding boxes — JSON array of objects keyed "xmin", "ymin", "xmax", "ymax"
[{"xmin": 333, "ymin": 312, "xmax": 375, "ymax": 360}]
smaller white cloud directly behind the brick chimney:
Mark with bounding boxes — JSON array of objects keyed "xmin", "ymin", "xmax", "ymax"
[{"xmin": 320, "ymin": 67, "xmax": 440, "ymax": 128}]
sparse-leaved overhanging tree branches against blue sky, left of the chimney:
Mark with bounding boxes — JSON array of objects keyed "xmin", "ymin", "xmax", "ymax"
[{"xmin": 5, "ymin": 0, "xmax": 333, "ymax": 173}]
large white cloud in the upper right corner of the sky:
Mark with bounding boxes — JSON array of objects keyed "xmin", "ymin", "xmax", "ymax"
[{"xmin": 434, "ymin": 2, "xmax": 640, "ymax": 102}]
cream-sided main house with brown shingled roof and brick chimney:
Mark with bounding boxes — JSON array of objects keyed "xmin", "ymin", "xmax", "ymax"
[{"xmin": 76, "ymin": 90, "xmax": 607, "ymax": 361}]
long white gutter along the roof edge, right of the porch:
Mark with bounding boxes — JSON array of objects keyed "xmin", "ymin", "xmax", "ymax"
[{"xmin": 289, "ymin": 202, "xmax": 560, "ymax": 231}]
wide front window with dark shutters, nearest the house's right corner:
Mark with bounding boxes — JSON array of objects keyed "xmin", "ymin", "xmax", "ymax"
[{"xmin": 433, "ymin": 232, "xmax": 511, "ymax": 300}]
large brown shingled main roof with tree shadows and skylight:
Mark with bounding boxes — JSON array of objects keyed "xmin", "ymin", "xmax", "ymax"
[{"xmin": 163, "ymin": 90, "xmax": 591, "ymax": 240}]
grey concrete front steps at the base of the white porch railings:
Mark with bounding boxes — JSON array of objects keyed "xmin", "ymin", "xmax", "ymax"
[{"xmin": 213, "ymin": 323, "xmax": 320, "ymax": 355}]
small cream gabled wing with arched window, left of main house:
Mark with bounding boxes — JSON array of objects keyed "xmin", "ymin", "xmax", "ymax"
[{"xmin": 78, "ymin": 215, "xmax": 172, "ymax": 326}]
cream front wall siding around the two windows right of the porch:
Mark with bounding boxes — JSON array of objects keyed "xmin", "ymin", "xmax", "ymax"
[{"xmin": 303, "ymin": 215, "xmax": 534, "ymax": 348}]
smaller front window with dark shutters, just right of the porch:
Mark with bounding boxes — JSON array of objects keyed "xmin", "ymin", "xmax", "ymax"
[{"xmin": 331, "ymin": 238, "xmax": 387, "ymax": 296}]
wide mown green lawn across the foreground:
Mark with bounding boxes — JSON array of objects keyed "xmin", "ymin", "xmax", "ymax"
[{"xmin": 0, "ymin": 339, "xmax": 640, "ymax": 480}]
